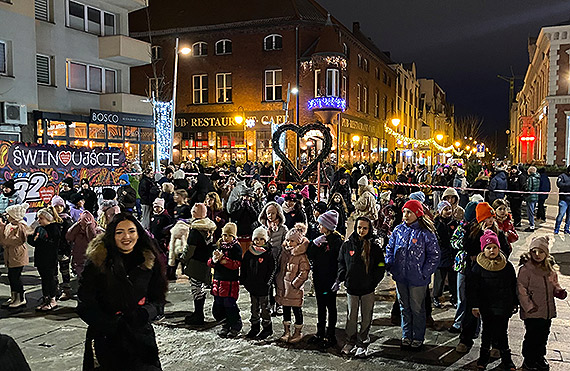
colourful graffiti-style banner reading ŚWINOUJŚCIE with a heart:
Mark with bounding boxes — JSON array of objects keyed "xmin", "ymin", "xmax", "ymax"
[{"xmin": 0, "ymin": 141, "xmax": 127, "ymax": 209}]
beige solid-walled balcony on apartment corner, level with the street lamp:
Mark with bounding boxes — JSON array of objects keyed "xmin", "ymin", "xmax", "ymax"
[{"xmin": 99, "ymin": 35, "xmax": 150, "ymax": 67}]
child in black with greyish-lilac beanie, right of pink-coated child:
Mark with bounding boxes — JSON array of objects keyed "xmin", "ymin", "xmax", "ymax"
[{"xmin": 307, "ymin": 210, "xmax": 344, "ymax": 348}]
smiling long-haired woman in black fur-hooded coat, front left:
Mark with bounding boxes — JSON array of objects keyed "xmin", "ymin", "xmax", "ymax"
[{"xmin": 77, "ymin": 214, "xmax": 167, "ymax": 370}]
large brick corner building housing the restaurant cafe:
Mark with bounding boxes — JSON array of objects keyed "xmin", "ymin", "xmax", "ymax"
[{"xmin": 130, "ymin": 0, "xmax": 396, "ymax": 164}]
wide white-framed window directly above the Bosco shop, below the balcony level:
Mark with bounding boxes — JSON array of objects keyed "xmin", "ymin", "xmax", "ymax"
[{"xmin": 66, "ymin": 61, "xmax": 117, "ymax": 94}]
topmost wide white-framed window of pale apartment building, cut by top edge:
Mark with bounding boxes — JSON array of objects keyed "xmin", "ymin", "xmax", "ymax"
[{"xmin": 66, "ymin": 0, "xmax": 117, "ymax": 36}]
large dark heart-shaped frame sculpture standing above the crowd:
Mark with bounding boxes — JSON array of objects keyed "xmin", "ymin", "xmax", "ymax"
[{"xmin": 272, "ymin": 123, "xmax": 332, "ymax": 182}]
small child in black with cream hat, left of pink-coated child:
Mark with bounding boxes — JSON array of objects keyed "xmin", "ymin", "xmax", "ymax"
[{"xmin": 240, "ymin": 227, "xmax": 275, "ymax": 340}]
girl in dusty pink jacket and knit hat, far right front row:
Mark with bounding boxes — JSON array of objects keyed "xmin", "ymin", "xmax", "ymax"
[{"xmin": 517, "ymin": 236, "xmax": 566, "ymax": 370}]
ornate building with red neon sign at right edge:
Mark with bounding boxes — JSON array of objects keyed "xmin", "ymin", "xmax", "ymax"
[{"xmin": 509, "ymin": 21, "xmax": 570, "ymax": 166}]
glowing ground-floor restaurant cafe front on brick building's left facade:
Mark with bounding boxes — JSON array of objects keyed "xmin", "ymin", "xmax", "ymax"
[{"xmin": 174, "ymin": 110, "xmax": 286, "ymax": 164}]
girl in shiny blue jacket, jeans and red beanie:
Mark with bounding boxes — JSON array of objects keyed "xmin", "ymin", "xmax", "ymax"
[{"xmin": 386, "ymin": 200, "xmax": 440, "ymax": 350}]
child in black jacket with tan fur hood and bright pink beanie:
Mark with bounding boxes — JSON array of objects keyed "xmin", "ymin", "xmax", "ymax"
[{"xmin": 466, "ymin": 229, "xmax": 518, "ymax": 370}]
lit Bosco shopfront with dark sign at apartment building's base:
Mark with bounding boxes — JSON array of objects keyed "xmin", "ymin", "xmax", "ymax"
[{"xmin": 34, "ymin": 110, "xmax": 155, "ymax": 166}]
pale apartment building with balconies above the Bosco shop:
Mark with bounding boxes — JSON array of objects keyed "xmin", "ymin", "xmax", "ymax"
[{"xmin": 0, "ymin": 0, "xmax": 155, "ymax": 161}]
